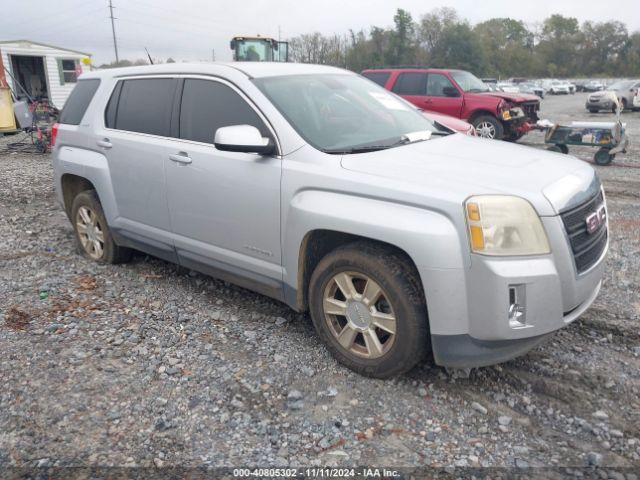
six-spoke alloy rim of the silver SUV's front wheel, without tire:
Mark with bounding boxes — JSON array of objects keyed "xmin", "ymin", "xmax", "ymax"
[{"xmin": 322, "ymin": 272, "xmax": 397, "ymax": 359}]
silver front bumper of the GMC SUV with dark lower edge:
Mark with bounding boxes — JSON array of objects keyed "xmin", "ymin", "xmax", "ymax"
[{"xmin": 421, "ymin": 216, "xmax": 608, "ymax": 367}]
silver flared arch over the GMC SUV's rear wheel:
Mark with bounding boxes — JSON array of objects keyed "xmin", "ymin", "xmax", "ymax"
[{"xmin": 54, "ymin": 146, "xmax": 118, "ymax": 224}]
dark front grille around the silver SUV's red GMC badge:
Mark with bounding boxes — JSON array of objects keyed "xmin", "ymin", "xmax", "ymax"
[{"xmin": 560, "ymin": 191, "xmax": 609, "ymax": 273}]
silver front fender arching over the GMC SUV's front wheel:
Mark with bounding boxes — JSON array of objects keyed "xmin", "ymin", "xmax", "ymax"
[{"xmin": 283, "ymin": 190, "xmax": 469, "ymax": 333}]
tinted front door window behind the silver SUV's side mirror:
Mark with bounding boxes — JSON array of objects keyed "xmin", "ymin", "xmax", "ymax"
[{"xmin": 180, "ymin": 80, "xmax": 271, "ymax": 143}]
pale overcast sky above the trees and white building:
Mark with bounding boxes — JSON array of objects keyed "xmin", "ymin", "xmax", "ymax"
[{"xmin": 0, "ymin": 0, "xmax": 640, "ymax": 65}]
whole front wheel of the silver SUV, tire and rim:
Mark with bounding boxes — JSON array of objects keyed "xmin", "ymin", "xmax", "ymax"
[{"xmin": 309, "ymin": 242, "xmax": 430, "ymax": 378}]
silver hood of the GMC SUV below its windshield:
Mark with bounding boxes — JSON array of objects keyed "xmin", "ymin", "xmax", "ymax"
[{"xmin": 341, "ymin": 135, "xmax": 597, "ymax": 216}]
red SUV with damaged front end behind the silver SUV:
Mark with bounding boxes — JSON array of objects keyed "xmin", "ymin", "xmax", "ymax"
[{"xmin": 362, "ymin": 68, "xmax": 540, "ymax": 141}]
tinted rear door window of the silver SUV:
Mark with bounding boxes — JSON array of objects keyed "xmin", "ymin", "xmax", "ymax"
[{"xmin": 114, "ymin": 78, "xmax": 176, "ymax": 136}]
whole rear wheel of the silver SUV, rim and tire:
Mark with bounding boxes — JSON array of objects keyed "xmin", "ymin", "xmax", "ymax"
[{"xmin": 71, "ymin": 190, "xmax": 131, "ymax": 263}]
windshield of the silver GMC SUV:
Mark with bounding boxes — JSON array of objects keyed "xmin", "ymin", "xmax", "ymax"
[{"xmin": 253, "ymin": 74, "xmax": 442, "ymax": 153}]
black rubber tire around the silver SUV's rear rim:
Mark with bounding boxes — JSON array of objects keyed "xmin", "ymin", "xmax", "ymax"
[{"xmin": 71, "ymin": 190, "xmax": 132, "ymax": 264}]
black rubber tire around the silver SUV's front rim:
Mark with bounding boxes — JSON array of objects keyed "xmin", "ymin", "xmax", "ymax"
[{"xmin": 309, "ymin": 241, "xmax": 431, "ymax": 378}]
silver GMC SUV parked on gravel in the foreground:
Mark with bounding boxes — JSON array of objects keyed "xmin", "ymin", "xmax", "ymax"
[{"xmin": 53, "ymin": 63, "xmax": 608, "ymax": 378}]
